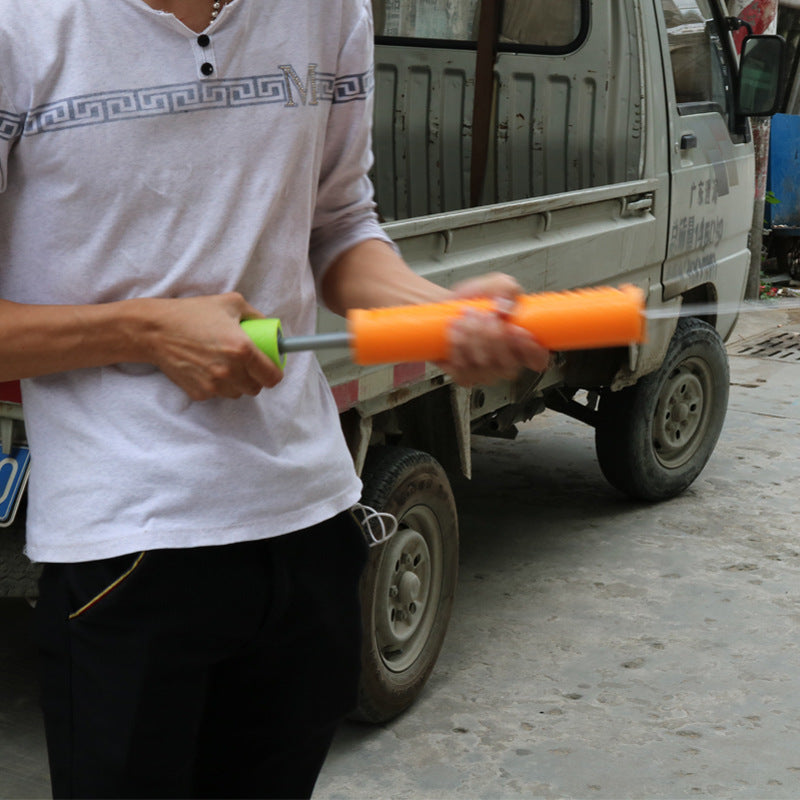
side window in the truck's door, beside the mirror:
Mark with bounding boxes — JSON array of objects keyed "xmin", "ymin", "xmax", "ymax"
[{"xmin": 662, "ymin": 0, "xmax": 732, "ymax": 121}]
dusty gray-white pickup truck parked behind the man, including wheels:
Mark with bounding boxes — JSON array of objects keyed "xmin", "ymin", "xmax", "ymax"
[{"xmin": 0, "ymin": 0, "xmax": 779, "ymax": 720}]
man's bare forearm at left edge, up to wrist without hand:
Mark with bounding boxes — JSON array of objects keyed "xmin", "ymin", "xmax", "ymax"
[{"xmin": 0, "ymin": 300, "xmax": 153, "ymax": 380}]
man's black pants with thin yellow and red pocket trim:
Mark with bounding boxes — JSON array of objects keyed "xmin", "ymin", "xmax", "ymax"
[{"xmin": 37, "ymin": 514, "xmax": 367, "ymax": 798}]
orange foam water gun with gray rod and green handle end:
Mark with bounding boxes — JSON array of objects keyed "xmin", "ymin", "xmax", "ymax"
[{"xmin": 242, "ymin": 286, "xmax": 647, "ymax": 366}]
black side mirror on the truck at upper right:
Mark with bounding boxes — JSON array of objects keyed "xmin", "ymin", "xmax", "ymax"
[{"xmin": 736, "ymin": 34, "xmax": 786, "ymax": 117}]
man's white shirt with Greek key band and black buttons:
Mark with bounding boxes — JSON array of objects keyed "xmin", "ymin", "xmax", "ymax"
[{"xmin": 0, "ymin": 0, "xmax": 386, "ymax": 561}]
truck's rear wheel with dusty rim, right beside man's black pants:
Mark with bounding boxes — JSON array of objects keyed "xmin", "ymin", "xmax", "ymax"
[{"xmin": 354, "ymin": 447, "xmax": 458, "ymax": 722}]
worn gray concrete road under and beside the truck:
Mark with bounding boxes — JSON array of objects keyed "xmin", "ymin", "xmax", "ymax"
[{"xmin": 0, "ymin": 313, "xmax": 800, "ymax": 800}]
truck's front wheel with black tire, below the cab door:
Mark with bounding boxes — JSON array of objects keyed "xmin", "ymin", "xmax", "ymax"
[{"xmin": 595, "ymin": 317, "xmax": 730, "ymax": 500}]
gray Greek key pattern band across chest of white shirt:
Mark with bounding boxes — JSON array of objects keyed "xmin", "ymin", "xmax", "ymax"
[{"xmin": 0, "ymin": 71, "xmax": 374, "ymax": 140}]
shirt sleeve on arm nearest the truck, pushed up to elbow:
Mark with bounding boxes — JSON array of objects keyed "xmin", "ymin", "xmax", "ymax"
[{"xmin": 309, "ymin": 0, "xmax": 391, "ymax": 294}]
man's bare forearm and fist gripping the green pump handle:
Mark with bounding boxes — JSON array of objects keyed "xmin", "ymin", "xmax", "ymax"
[{"xmin": 0, "ymin": 292, "xmax": 283, "ymax": 400}]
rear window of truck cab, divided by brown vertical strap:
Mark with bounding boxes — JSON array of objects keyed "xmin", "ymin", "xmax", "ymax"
[{"xmin": 372, "ymin": 0, "xmax": 588, "ymax": 50}]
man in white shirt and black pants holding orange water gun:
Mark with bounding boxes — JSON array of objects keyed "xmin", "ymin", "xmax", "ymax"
[{"xmin": 0, "ymin": 0, "xmax": 547, "ymax": 797}]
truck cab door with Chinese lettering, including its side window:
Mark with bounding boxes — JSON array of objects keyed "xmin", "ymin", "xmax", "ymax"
[{"xmin": 660, "ymin": 0, "xmax": 755, "ymax": 337}]
